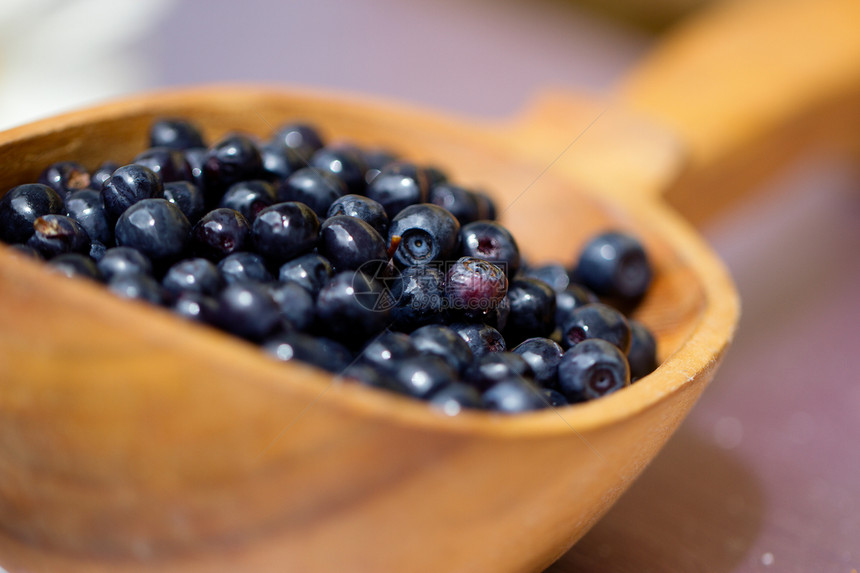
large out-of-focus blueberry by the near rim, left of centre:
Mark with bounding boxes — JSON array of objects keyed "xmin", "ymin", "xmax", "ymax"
[{"xmin": 213, "ymin": 282, "xmax": 280, "ymax": 342}]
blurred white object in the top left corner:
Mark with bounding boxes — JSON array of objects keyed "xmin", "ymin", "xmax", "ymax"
[{"xmin": 0, "ymin": 0, "xmax": 171, "ymax": 129}]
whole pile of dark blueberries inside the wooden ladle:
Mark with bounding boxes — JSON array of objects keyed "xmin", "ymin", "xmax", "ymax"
[{"xmin": 0, "ymin": 119, "xmax": 656, "ymax": 414}]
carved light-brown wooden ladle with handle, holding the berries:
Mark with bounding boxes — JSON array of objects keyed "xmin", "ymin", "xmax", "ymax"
[{"xmin": 0, "ymin": 0, "xmax": 860, "ymax": 573}]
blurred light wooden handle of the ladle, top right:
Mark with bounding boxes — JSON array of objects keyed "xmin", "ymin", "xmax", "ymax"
[{"xmin": 617, "ymin": 0, "xmax": 860, "ymax": 223}]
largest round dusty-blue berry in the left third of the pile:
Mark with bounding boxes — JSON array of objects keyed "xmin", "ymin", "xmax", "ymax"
[{"xmin": 115, "ymin": 199, "xmax": 191, "ymax": 266}]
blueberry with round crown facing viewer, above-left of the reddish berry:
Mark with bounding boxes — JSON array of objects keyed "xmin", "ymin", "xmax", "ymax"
[{"xmin": 388, "ymin": 203, "xmax": 460, "ymax": 267}]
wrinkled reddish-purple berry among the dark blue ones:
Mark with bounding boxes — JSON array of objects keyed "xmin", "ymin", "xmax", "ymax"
[{"xmin": 445, "ymin": 257, "xmax": 508, "ymax": 317}]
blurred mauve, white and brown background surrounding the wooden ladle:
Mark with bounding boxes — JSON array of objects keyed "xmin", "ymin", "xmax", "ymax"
[{"xmin": 0, "ymin": 0, "xmax": 860, "ymax": 573}]
